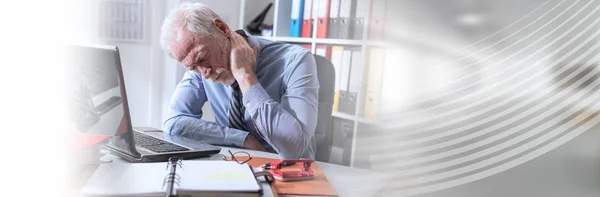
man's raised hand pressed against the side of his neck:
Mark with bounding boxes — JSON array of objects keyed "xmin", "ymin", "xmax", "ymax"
[{"xmin": 229, "ymin": 31, "xmax": 258, "ymax": 94}]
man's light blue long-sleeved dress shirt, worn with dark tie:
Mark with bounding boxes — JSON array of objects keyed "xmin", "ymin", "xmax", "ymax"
[{"xmin": 164, "ymin": 33, "xmax": 319, "ymax": 159}]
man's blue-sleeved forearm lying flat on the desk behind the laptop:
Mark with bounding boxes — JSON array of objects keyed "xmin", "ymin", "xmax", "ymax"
[{"xmin": 164, "ymin": 116, "xmax": 248, "ymax": 147}]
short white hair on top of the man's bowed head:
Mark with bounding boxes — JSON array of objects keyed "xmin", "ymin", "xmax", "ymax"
[{"xmin": 160, "ymin": 2, "xmax": 219, "ymax": 54}]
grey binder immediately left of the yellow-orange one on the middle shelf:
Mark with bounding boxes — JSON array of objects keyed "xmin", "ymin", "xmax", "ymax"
[{"xmin": 345, "ymin": 50, "xmax": 363, "ymax": 115}]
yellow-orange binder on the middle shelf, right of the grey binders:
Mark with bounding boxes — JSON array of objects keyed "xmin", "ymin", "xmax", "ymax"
[{"xmin": 363, "ymin": 48, "xmax": 385, "ymax": 120}]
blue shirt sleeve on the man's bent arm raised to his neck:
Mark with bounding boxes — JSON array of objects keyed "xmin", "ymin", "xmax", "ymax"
[{"xmin": 243, "ymin": 53, "xmax": 319, "ymax": 159}]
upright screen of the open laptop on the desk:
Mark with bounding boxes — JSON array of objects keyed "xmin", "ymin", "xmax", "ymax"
[{"xmin": 67, "ymin": 46, "xmax": 130, "ymax": 136}]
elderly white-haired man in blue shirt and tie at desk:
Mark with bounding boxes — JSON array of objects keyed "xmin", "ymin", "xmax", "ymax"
[{"xmin": 161, "ymin": 3, "xmax": 319, "ymax": 159}]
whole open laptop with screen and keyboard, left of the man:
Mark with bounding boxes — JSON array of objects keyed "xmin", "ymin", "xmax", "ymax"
[{"xmin": 67, "ymin": 46, "xmax": 221, "ymax": 162}]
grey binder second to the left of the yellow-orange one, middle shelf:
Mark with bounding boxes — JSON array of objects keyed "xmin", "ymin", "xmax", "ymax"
[{"xmin": 339, "ymin": 49, "xmax": 352, "ymax": 114}]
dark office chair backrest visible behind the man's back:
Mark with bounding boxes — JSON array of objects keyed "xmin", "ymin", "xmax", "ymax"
[{"xmin": 314, "ymin": 55, "xmax": 335, "ymax": 161}]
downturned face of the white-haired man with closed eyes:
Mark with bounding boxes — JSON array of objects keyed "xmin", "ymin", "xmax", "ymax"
[{"xmin": 171, "ymin": 28, "xmax": 235, "ymax": 85}]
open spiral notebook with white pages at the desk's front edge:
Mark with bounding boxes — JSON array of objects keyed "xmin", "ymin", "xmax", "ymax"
[{"xmin": 81, "ymin": 161, "xmax": 261, "ymax": 196}]
